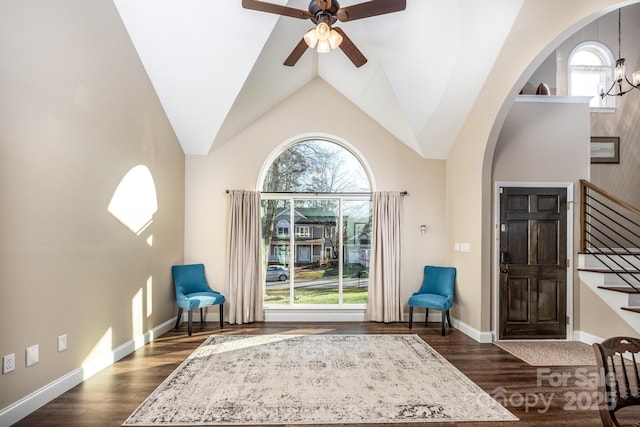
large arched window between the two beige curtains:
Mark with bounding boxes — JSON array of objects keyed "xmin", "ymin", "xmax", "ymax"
[{"xmin": 262, "ymin": 138, "xmax": 372, "ymax": 308}]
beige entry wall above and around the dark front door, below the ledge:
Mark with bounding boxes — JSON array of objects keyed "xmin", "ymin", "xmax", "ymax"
[{"xmin": 492, "ymin": 95, "xmax": 631, "ymax": 337}]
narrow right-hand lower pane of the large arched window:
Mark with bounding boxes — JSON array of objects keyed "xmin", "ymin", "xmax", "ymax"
[{"xmin": 342, "ymin": 201, "xmax": 371, "ymax": 304}]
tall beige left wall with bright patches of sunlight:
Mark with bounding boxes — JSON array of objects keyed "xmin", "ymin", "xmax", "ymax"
[{"xmin": 0, "ymin": 0, "xmax": 184, "ymax": 416}]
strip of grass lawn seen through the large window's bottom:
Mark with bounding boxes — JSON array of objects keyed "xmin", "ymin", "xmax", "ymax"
[{"xmin": 264, "ymin": 287, "xmax": 368, "ymax": 304}]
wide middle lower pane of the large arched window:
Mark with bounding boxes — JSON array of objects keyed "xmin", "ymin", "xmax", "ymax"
[{"xmin": 294, "ymin": 200, "xmax": 340, "ymax": 304}]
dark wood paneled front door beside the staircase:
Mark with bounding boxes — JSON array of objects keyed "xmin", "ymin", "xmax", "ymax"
[{"xmin": 499, "ymin": 187, "xmax": 567, "ymax": 339}]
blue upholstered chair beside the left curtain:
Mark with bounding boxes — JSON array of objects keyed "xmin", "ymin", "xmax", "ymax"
[{"xmin": 171, "ymin": 264, "xmax": 224, "ymax": 336}]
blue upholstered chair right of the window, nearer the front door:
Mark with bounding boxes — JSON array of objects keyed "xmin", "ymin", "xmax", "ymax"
[{"xmin": 409, "ymin": 265, "xmax": 456, "ymax": 336}]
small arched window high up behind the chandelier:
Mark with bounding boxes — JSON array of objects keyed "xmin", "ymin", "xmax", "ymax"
[{"xmin": 568, "ymin": 41, "xmax": 616, "ymax": 109}]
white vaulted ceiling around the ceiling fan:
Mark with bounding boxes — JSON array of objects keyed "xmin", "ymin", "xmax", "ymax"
[{"xmin": 114, "ymin": 0, "xmax": 523, "ymax": 159}]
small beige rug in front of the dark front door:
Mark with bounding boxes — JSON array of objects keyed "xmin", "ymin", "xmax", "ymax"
[{"xmin": 494, "ymin": 341, "xmax": 596, "ymax": 366}]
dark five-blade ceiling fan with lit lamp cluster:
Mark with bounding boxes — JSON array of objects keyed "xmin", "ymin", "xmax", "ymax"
[{"xmin": 242, "ymin": 0, "xmax": 407, "ymax": 67}]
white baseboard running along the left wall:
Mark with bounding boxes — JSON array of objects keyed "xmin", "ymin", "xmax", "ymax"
[{"xmin": 0, "ymin": 318, "xmax": 176, "ymax": 427}]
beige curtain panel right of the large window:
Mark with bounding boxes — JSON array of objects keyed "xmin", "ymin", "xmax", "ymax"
[{"xmin": 367, "ymin": 191, "xmax": 402, "ymax": 323}]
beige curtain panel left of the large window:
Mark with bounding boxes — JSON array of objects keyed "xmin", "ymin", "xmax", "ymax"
[{"xmin": 227, "ymin": 190, "xmax": 264, "ymax": 325}]
